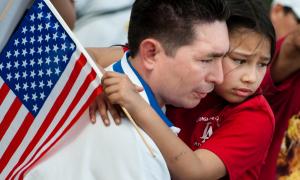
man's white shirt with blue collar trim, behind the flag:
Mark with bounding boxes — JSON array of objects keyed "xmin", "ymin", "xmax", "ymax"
[{"xmin": 24, "ymin": 52, "xmax": 170, "ymax": 180}]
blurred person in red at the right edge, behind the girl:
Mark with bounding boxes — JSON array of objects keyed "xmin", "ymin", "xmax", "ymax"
[{"xmin": 260, "ymin": 0, "xmax": 300, "ymax": 179}]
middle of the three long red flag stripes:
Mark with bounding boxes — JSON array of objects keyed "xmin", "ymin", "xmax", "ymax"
[{"xmin": 17, "ymin": 70, "xmax": 96, "ymax": 177}]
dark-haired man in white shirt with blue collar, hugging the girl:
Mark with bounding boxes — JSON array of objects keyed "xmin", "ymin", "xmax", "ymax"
[{"xmin": 25, "ymin": 0, "xmax": 229, "ymax": 180}]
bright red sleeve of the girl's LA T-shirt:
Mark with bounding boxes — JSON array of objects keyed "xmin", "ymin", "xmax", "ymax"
[{"xmin": 200, "ymin": 97, "xmax": 274, "ymax": 180}]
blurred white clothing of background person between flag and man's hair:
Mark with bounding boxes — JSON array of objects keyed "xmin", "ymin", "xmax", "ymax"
[{"xmin": 74, "ymin": 0, "xmax": 134, "ymax": 47}]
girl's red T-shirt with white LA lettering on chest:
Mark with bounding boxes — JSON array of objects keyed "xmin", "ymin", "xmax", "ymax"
[{"xmin": 167, "ymin": 94, "xmax": 274, "ymax": 180}]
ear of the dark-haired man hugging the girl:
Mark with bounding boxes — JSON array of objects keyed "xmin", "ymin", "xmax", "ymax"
[{"xmin": 139, "ymin": 38, "xmax": 164, "ymax": 70}]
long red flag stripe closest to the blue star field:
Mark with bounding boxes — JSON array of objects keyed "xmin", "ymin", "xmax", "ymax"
[{"xmin": 8, "ymin": 55, "xmax": 86, "ymax": 177}]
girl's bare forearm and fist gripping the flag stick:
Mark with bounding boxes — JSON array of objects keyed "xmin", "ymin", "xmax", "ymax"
[{"xmin": 103, "ymin": 72, "xmax": 226, "ymax": 180}]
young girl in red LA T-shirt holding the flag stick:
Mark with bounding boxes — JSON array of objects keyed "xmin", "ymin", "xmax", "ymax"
[{"xmin": 95, "ymin": 0, "xmax": 275, "ymax": 179}]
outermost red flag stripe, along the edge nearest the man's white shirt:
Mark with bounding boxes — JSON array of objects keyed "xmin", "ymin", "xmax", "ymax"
[{"xmin": 20, "ymin": 85, "xmax": 102, "ymax": 179}]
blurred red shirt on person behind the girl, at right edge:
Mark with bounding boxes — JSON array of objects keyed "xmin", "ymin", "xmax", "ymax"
[{"xmin": 260, "ymin": 39, "xmax": 300, "ymax": 179}]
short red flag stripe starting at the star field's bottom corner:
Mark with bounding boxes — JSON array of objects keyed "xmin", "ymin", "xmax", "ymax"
[{"xmin": 0, "ymin": 113, "xmax": 34, "ymax": 173}]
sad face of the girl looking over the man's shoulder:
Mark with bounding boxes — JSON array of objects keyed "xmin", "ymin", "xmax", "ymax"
[{"xmin": 215, "ymin": 28, "xmax": 271, "ymax": 103}]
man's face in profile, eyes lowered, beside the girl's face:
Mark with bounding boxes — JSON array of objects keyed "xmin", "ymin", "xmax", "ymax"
[{"xmin": 152, "ymin": 21, "xmax": 229, "ymax": 108}]
